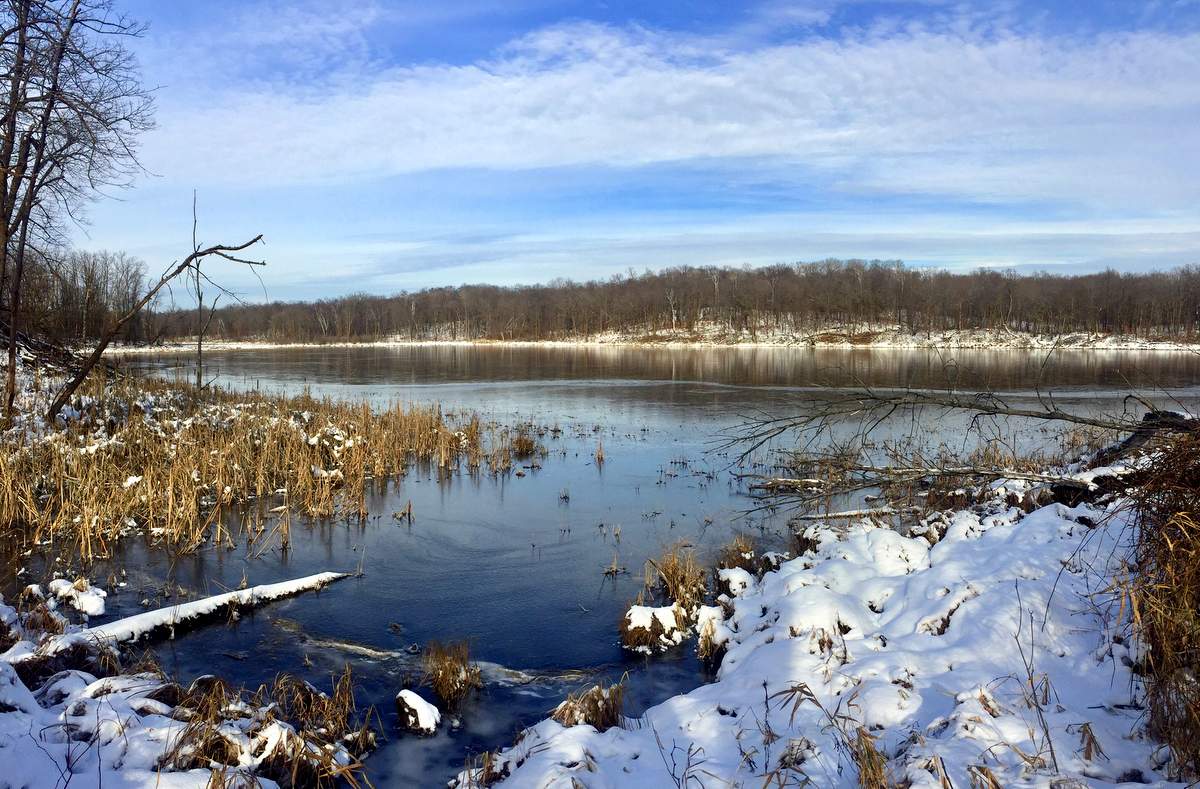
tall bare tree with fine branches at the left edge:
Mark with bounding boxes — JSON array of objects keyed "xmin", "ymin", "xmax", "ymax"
[{"xmin": 0, "ymin": 0, "xmax": 152, "ymax": 418}]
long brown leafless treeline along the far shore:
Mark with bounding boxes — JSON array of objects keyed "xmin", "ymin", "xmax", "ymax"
[{"xmin": 142, "ymin": 260, "xmax": 1200, "ymax": 342}]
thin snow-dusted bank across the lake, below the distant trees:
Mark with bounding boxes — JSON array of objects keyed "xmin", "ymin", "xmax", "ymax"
[{"xmin": 108, "ymin": 325, "xmax": 1200, "ymax": 356}]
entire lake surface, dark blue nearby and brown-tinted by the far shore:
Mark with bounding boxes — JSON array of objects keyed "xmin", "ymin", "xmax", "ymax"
[{"xmin": 28, "ymin": 347, "xmax": 1200, "ymax": 785}]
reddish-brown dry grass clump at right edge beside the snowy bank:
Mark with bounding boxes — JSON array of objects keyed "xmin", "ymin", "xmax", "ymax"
[{"xmin": 1126, "ymin": 438, "xmax": 1200, "ymax": 781}]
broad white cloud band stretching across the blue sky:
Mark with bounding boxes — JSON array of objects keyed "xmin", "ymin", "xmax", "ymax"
[{"xmin": 146, "ymin": 23, "xmax": 1200, "ymax": 209}]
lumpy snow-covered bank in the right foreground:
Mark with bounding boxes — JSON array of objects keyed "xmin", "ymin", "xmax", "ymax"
[{"xmin": 463, "ymin": 489, "xmax": 1166, "ymax": 789}]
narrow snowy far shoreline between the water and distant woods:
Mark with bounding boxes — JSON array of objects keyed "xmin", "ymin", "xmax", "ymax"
[{"xmin": 104, "ymin": 331, "xmax": 1200, "ymax": 356}]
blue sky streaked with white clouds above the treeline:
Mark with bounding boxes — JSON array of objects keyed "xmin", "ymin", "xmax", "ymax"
[{"xmin": 77, "ymin": 0, "xmax": 1200, "ymax": 301}]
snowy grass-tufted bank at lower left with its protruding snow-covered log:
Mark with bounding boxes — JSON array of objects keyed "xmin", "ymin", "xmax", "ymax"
[{"xmin": 0, "ymin": 573, "xmax": 368, "ymax": 788}]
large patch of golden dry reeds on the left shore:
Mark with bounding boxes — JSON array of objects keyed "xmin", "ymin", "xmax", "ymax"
[{"xmin": 0, "ymin": 369, "xmax": 487, "ymax": 561}]
